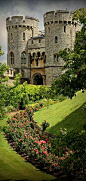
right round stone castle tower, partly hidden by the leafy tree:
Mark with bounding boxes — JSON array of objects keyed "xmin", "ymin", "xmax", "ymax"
[{"xmin": 44, "ymin": 10, "xmax": 80, "ymax": 85}]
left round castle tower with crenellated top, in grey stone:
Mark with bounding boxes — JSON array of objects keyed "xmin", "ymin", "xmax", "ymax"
[{"xmin": 6, "ymin": 16, "xmax": 39, "ymax": 82}]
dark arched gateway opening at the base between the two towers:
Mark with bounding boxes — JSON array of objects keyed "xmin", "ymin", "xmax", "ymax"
[{"xmin": 33, "ymin": 73, "xmax": 43, "ymax": 85}]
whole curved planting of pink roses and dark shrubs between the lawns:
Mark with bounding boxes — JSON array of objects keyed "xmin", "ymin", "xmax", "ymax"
[{"xmin": 4, "ymin": 108, "xmax": 86, "ymax": 179}]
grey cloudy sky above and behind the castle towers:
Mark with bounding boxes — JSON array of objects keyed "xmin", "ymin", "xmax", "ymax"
[{"xmin": 0, "ymin": 0, "xmax": 86, "ymax": 62}]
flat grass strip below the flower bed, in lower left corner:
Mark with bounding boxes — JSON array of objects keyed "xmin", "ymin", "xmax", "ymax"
[{"xmin": 0, "ymin": 116, "xmax": 55, "ymax": 181}]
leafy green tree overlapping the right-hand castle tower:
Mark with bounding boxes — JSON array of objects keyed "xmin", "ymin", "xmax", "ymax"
[{"xmin": 52, "ymin": 8, "xmax": 86, "ymax": 98}]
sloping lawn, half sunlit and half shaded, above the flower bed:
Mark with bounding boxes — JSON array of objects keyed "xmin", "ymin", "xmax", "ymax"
[{"xmin": 34, "ymin": 92, "xmax": 86, "ymax": 134}]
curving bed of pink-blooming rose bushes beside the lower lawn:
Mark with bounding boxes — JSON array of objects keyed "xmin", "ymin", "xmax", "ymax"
[{"xmin": 4, "ymin": 108, "xmax": 72, "ymax": 177}]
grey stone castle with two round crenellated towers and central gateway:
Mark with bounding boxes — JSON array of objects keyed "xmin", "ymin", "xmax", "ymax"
[{"xmin": 6, "ymin": 9, "xmax": 81, "ymax": 85}]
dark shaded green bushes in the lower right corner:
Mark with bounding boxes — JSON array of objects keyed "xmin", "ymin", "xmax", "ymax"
[{"xmin": 51, "ymin": 130, "xmax": 86, "ymax": 180}]
